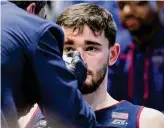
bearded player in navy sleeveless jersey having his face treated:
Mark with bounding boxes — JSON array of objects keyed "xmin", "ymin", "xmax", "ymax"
[{"xmin": 23, "ymin": 4, "xmax": 164, "ymax": 128}]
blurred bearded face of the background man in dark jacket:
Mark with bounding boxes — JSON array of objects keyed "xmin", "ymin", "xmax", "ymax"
[{"xmin": 118, "ymin": 1, "xmax": 154, "ymax": 32}]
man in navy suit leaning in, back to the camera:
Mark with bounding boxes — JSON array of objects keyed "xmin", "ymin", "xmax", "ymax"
[{"xmin": 1, "ymin": 1, "xmax": 95, "ymax": 128}]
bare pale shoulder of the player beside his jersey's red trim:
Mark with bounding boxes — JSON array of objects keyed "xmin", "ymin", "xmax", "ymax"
[{"xmin": 139, "ymin": 107, "xmax": 164, "ymax": 128}]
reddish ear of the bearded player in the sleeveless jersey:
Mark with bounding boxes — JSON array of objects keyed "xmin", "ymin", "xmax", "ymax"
[{"xmin": 109, "ymin": 43, "xmax": 120, "ymax": 66}]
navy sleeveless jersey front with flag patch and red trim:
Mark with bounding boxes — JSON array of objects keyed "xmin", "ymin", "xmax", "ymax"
[{"xmin": 95, "ymin": 100, "xmax": 143, "ymax": 128}]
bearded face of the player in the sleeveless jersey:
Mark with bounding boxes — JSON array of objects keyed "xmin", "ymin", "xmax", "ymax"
[{"xmin": 62, "ymin": 25, "xmax": 109, "ymax": 94}]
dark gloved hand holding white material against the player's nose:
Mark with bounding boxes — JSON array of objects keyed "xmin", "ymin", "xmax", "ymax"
[{"xmin": 63, "ymin": 51, "xmax": 87, "ymax": 89}]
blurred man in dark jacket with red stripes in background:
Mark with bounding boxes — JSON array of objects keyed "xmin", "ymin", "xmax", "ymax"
[{"xmin": 109, "ymin": 1, "xmax": 164, "ymax": 111}]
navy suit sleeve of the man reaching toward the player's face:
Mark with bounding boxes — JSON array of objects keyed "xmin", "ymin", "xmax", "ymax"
[{"xmin": 33, "ymin": 24, "xmax": 96, "ymax": 128}]
